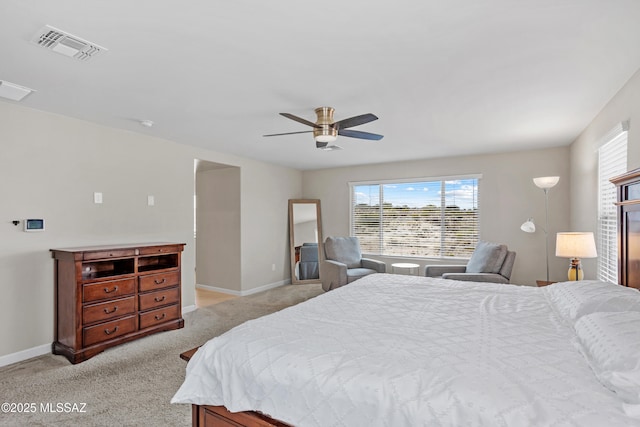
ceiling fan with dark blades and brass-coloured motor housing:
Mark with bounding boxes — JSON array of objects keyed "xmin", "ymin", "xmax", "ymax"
[{"xmin": 263, "ymin": 107, "xmax": 383, "ymax": 150}]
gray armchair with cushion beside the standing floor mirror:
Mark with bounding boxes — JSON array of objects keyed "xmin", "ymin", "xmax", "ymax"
[{"xmin": 320, "ymin": 237, "xmax": 386, "ymax": 291}]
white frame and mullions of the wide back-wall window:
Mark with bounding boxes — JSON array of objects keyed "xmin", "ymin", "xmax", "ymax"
[{"xmin": 347, "ymin": 173, "xmax": 482, "ymax": 260}]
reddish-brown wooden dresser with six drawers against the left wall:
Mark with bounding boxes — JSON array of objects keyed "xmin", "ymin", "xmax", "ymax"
[{"xmin": 51, "ymin": 243, "xmax": 185, "ymax": 363}]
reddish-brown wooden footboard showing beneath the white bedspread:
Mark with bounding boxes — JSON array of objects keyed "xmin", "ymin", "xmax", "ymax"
[{"xmin": 180, "ymin": 347, "xmax": 291, "ymax": 427}]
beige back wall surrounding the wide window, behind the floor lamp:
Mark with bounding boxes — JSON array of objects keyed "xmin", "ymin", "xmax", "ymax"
[{"xmin": 303, "ymin": 147, "xmax": 570, "ymax": 285}]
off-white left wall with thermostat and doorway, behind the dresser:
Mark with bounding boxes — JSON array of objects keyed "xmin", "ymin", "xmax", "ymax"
[{"xmin": 0, "ymin": 102, "xmax": 301, "ymax": 365}]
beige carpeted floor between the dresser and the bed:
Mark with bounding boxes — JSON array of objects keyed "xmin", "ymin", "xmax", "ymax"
[{"xmin": 0, "ymin": 284, "xmax": 322, "ymax": 427}]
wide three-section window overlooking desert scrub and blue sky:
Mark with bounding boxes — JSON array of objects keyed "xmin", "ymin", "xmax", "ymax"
[{"xmin": 349, "ymin": 176, "xmax": 480, "ymax": 258}]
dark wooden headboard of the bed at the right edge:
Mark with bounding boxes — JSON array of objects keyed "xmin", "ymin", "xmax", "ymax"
[{"xmin": 611, "ymin": 169, "xmax": 640, "ymax": 289}]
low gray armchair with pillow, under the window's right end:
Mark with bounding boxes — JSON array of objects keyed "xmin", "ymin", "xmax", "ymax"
[{"xmin": 425, "ymin": 241, "xmax": 516, "ymax": 283}]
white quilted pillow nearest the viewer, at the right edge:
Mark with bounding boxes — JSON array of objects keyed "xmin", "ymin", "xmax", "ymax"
[{"xmin": 575, "ymin": 311, "xmax": 640, "ymax": 404}]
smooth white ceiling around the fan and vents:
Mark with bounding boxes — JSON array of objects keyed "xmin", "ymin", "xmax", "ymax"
[{"xmin": 0, "ymin": 0, "xmax": 640, "ymax": 169}]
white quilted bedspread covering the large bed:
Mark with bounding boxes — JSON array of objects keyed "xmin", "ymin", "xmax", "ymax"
[{"xmin": 172, "ymin": 274, "xmax": 640, "ymax": 427}]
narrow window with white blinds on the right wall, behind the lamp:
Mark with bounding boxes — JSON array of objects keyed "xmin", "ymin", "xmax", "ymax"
[{"xmin": 597, "ymin": 123, "xmax": 628, "ymax": 283}]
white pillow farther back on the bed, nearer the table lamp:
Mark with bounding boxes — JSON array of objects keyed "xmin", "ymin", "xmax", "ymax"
[{"xmin": 542, "ymin": 280, "xmax": 640, "ymax": 321}]
